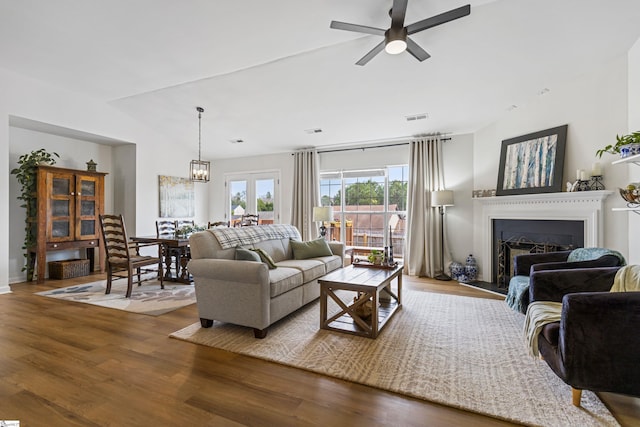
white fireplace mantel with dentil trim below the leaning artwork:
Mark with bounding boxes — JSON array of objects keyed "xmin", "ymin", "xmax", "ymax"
[{"xmin": 473, "ymin": 190, "xmax": 613, "ymax": 280}]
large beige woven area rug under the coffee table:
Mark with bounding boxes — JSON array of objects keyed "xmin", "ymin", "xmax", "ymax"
[{"xmin": 171, "ymin": 291, "xmax": 618, "ymax": 427}]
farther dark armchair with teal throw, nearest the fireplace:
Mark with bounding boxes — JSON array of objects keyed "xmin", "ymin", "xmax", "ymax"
[{"xmin": 506, "ymin": 248, "xmax": 626, "ymax": 314}]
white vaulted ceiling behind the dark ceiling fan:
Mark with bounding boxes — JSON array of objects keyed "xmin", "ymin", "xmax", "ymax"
[{"xmin": 0, "ymin": 0, "xmax": 640, "ymax": 159}]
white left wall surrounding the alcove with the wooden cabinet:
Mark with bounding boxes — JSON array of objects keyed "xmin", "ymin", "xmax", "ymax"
[{"xmin": 0, "ymin": 69, "xmax": 208, "ymax": 293}]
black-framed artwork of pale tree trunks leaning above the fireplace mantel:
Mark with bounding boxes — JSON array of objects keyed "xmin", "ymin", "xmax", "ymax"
[{"xmin": 496, "ymin": 125, "xmax": 567, "ymax": 196}]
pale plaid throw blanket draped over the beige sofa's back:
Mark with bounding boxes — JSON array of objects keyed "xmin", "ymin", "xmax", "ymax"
[{"xmin": 208, "ymin": 224, "xmax": 300, "ymax": 249}]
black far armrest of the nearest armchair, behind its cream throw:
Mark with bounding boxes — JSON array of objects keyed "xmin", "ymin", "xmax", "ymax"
[{"xmin": 529, "ymin": 267, "xmax": 620, "ymax": 302}]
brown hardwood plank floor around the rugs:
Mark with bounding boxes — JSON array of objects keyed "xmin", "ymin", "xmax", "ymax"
[{"xmin": 0, "ymin": 275, "xmax": 640, "ymax": 426}]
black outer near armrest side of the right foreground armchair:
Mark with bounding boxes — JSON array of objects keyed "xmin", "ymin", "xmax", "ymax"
[{"xmin": 558, "ymin": 292, "xmax": 640, "ymax": 395}]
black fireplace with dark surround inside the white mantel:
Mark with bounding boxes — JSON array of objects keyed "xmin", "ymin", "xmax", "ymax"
[{"xmin": 491, "ymin": 219, "xmax": 584, "ymax": 290}]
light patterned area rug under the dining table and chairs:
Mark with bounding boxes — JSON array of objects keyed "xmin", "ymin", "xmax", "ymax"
[{"xmin": 36, "ymin": 279, "xmax": 196, "ymax": 316}]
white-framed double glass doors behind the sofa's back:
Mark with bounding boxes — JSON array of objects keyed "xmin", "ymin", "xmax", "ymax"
[{"xmin": 225, "ymin": 172, "xmax": 280, "ymax": 225}]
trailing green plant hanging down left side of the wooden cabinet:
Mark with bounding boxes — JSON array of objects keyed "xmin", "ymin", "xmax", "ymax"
[{"xmin": 11, "ymin": 148, "xmax": 60, "ymax": 278}]
